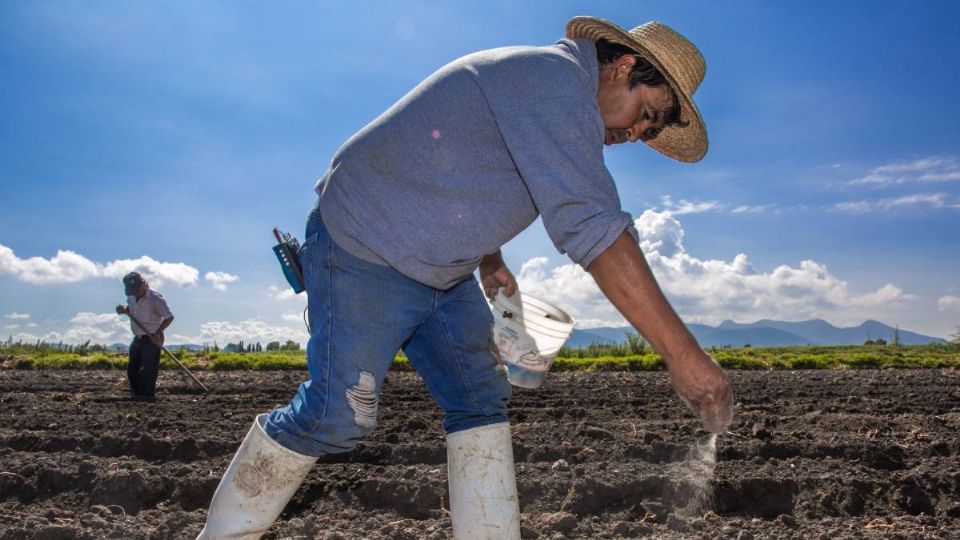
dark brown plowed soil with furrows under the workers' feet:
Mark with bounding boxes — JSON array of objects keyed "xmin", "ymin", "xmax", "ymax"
[{"xmin": 0, "ymin": 364, "xmax": 960, "ymax": 540}]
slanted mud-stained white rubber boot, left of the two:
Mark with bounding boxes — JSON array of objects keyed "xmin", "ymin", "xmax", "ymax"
[{"xmin": 197, "ymin": 414, "xmax": 317, "ymax": 540}]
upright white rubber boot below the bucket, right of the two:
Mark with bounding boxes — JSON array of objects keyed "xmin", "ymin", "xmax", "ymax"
[{"xmin": 447, "ymin": 423, "xmax": 520, "ymax": 540}]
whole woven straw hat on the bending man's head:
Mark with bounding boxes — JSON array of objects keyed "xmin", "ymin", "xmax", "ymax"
[{"xmin": 566, "ymin": 17, "xmax": 707, "ymax": 162}]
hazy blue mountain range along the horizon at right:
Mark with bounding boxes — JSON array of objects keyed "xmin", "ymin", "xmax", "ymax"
[{"xmin": 566, "ymin": 319, "xmax": 944, "ymax": 347}]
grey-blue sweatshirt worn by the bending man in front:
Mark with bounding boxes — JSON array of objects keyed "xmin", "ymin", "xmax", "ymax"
[{"xmin": 316, "ymin": 39, "xmax": 637, "ymax": 289}]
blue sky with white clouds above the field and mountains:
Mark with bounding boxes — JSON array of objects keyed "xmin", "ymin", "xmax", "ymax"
[{"xmin": 0, "ymin": 1, "xmax": 960, "ymax": 344}]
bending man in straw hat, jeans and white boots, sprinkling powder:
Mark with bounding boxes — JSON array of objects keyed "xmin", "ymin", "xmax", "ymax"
[{"xmin": 200, "ymin": 17, "xmax": 733, "ymax": 539}]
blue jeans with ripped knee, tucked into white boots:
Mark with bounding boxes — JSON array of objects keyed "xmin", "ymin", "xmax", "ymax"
[{"xmin": 264, "ymin": 205, "xmax": 511, "ymax": 456}]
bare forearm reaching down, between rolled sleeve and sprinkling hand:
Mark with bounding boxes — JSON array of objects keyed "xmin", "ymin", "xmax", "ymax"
[{"xmin": 588, "ymin": 232, "xmax": 699, "ymax": 363}]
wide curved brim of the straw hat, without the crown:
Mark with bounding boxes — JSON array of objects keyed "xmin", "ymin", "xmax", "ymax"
[{"xmin": 566, "ymin": 16, "xmax": 709, "ymax": 163}]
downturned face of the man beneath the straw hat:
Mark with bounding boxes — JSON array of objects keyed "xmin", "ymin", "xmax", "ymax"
[{"xmin": 597, "ymin": 55, "xmax": 673, "ymax": 144}]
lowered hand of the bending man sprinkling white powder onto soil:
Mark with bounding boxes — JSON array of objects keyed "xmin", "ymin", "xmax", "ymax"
[{"xmin": 667, "ymin": 350, "xmax": 733, "ymax": 435}]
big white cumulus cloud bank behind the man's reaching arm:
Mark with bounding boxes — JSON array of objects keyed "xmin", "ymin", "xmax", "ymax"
[{"xmin": 517, "ymin": 210, "xmax": 917, "ymax": 328}]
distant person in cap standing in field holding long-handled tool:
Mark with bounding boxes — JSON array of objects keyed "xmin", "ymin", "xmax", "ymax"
[{"xmin": 117, "ymin": 272, "xmax": 173, "ymax": 400}]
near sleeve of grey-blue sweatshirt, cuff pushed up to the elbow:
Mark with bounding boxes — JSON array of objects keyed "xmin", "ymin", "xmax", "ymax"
[{"xmin": 498, "ymin": 98, "xmax": 638, "ymax": 269}]
